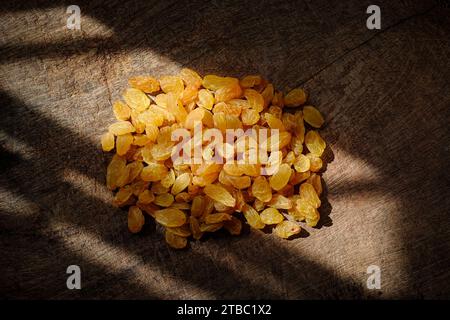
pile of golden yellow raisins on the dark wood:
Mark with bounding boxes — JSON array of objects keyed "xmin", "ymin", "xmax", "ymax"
[{"xmin": 101, "ymin": 69, "xmax": 325, "ymax": 248}]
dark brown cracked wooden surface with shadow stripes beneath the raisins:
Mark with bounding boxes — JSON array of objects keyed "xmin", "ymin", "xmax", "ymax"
[{"xmin": 0, "ymin": 0, "xmax": 450, "ymax": 299}]
